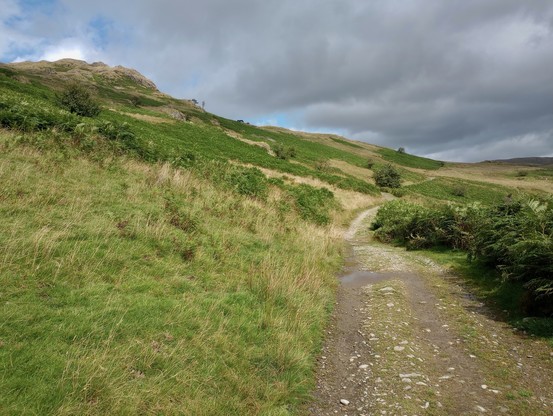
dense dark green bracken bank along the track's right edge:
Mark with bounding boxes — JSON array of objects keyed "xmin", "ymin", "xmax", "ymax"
[{"xmin": 373, "ymin": 200, "xmax": 553, "ymax": 316}]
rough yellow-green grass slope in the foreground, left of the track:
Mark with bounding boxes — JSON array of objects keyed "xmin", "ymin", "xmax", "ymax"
[{"xmin": 0, "ymin": 135, "xmax": 339, "ymax": 415}]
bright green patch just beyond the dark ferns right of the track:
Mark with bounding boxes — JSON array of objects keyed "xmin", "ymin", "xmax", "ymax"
[{"xmin": 405, "ymin": 178, "xmax": 513, "ymax": 204}]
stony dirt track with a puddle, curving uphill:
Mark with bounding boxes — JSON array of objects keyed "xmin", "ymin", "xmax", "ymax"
[{"xmin": 309, "ymin": 208, "xmax": 553, "ymax": 416}]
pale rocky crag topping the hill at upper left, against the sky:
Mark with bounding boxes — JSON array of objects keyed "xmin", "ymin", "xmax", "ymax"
[{"xmin": 5, "ymin": 59, "xmax": 158, "ymax": 92}]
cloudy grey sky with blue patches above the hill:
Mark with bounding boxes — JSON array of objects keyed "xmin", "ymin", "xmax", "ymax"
[{"xmin": 0, "ymin": 0, "xmax": 553, "ymax": 161}]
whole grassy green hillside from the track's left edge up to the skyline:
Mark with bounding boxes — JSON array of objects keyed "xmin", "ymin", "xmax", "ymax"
[{"xmin": 0, "ymin": 60, "xmax": 551, "ymax": 415}]
